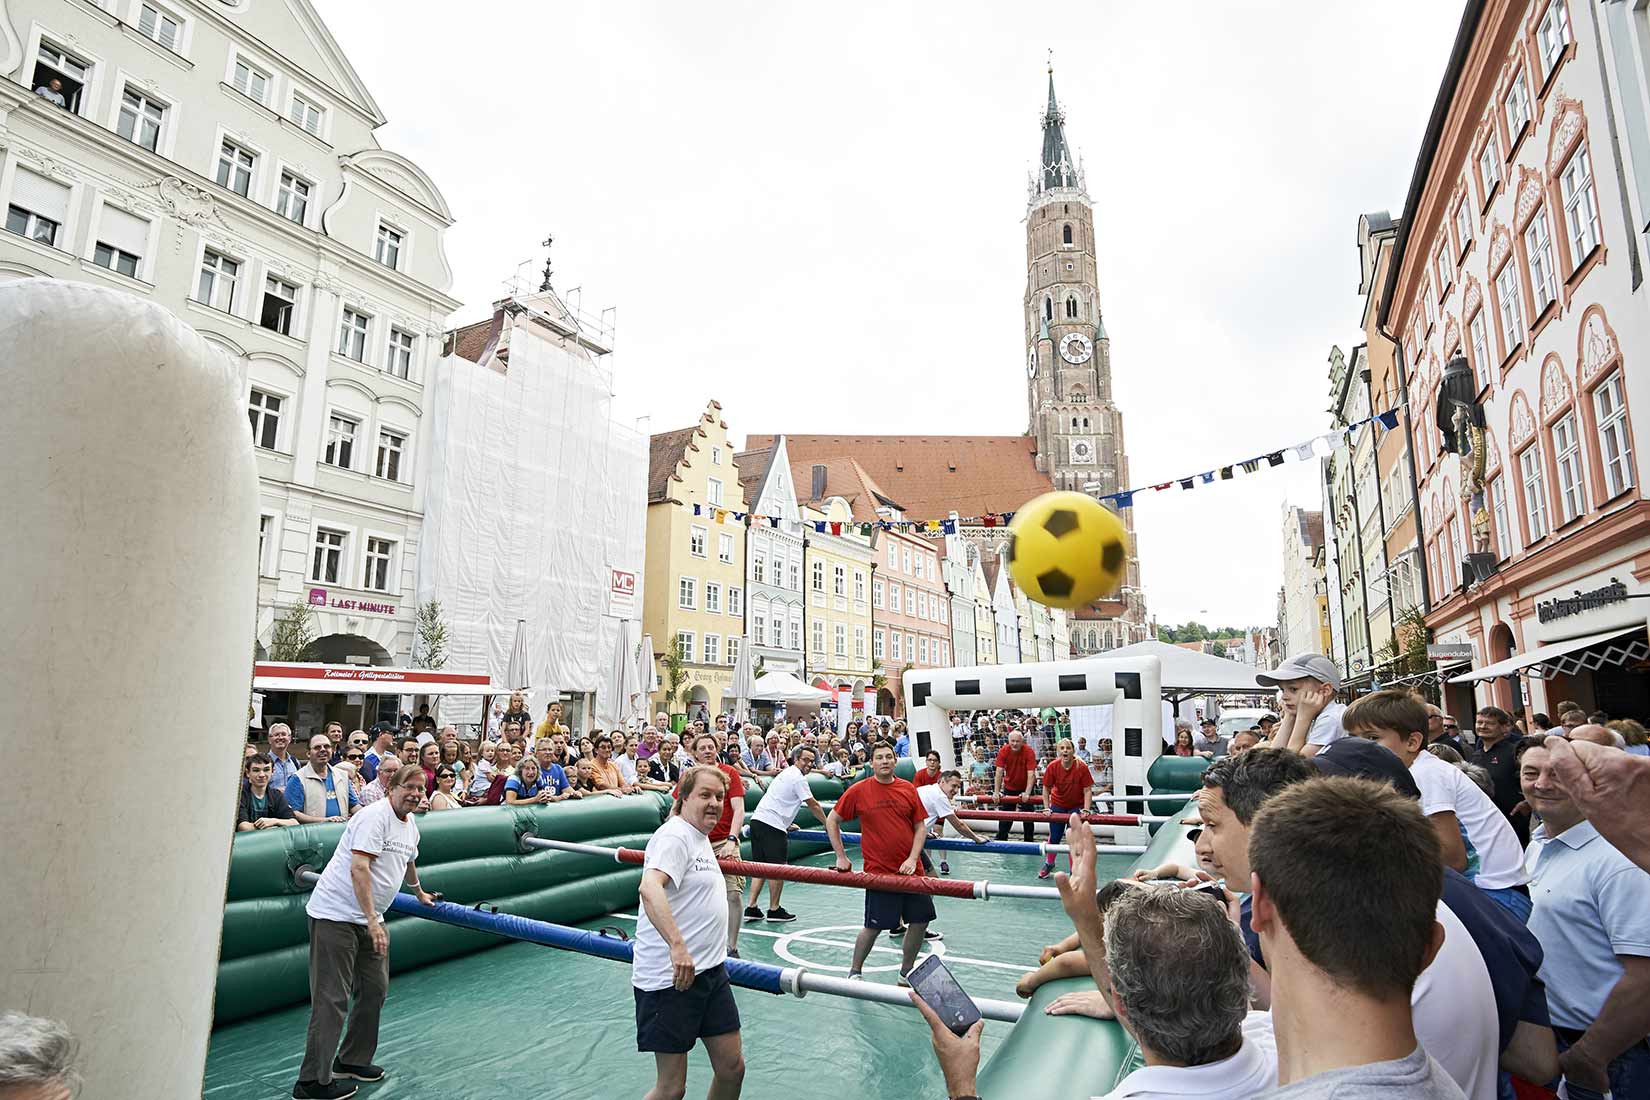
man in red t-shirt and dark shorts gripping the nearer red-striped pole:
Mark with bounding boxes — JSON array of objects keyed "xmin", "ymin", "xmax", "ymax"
[{"xmin": 825, "ymin": 740, "xmax": 934, "ymax": 985}]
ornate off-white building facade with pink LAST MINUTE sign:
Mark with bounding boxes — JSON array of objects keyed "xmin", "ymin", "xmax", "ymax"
[{"xmin": 0, "ymin": 0, "xmax": 457, "ymax": 679}]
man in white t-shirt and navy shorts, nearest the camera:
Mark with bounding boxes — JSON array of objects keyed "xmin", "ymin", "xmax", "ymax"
[{"xmin": 630, "ymin": 767, "xmax": 744, "ymax": 1097}]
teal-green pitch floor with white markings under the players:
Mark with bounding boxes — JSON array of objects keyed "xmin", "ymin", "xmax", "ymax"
[{"xmin": 205, "ymin": 849, "xmax": 1135, "ymax": 1100}]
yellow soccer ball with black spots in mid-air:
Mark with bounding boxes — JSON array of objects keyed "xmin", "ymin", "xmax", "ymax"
[{"xmin": 1008, "ymin": 491, "xmax": 1129, "ymax": 609}]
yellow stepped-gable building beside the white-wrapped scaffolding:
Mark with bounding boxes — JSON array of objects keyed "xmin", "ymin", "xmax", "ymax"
[{"xmin": 642, "ymin": 401, "xmax": 744, "ymax": 717}]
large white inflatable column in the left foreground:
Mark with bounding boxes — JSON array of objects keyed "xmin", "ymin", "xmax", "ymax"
[{"xmin": 0, "ymin": 279, "xmax": 257, "ymax": 1100}]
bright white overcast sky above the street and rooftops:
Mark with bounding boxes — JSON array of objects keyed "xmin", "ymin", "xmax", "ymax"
[{"xmin": 317, "ymin": 0, "xmax": 1460, "ymax": 625}]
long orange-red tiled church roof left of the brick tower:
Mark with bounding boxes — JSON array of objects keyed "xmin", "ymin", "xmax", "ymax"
[{"xmin": 746, "ymin": 434, "xmax": 1054, "ymax": 519}]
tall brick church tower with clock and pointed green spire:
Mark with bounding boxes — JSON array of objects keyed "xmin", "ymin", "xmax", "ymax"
[{"xmin": 1025, "ymin": 68, "xmax": 1147, "ymax": 651}]
